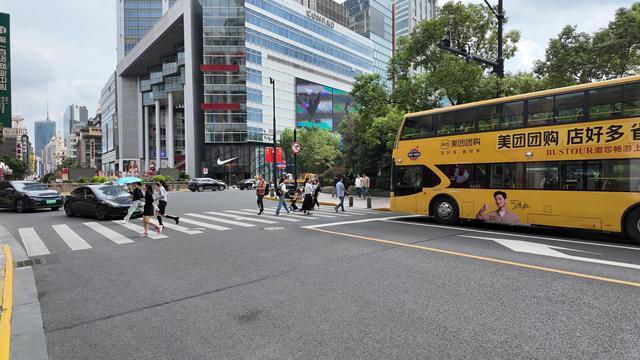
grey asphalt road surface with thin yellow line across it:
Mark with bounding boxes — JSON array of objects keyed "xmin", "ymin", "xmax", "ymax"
[{"xmin": 0, "ymin": 190, "xmax": 640, "ymax": 360}]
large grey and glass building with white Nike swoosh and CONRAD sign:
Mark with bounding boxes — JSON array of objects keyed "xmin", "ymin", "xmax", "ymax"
[{"xmin": 116, "ymin": 0, "xmax": 374, "ymax": 183}]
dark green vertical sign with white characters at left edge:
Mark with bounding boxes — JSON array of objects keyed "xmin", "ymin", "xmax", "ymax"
[{"xmin": 0, "ymin": 13, "xmax": 11, "ymax": 128}]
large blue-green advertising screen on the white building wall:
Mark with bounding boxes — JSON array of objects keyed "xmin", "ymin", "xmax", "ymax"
[{"xmin": 296, "ymin": 78, "xmax": 353, "ymax": 131}]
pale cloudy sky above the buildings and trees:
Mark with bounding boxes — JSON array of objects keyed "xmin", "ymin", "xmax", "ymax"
[{"xmin": 0, "ymin": 0, "xmax": 632, "ymax": 136}]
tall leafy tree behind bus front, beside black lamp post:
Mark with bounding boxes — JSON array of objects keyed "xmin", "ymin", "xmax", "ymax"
[{"xmin": 389, "ymin": 2, "xmax": 520, "ymax": 111}]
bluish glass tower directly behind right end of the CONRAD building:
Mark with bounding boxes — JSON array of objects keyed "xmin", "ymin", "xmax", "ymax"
[{"xmin": 344, "ymin": 0, "xmax": 393, "ymax": 84}]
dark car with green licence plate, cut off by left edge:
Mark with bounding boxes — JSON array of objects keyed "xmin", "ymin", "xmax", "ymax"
[{"xmin": 0, "ymin": 181, "xmax": 64, "ymax": 213}]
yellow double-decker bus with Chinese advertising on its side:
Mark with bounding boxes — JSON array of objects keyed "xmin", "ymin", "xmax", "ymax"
[{"xmin": 391, "ymin": 76, "xmax": 640, "ymax": 243}]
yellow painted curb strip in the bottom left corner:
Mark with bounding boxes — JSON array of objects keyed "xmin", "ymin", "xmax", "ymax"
[{"xmin": 0, "ymin": 245, "xmax": 13, "ymax": 360}]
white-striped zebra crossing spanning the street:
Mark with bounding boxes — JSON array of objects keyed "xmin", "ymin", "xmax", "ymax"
[{"xmin": 14, "ymin": 206, "xmax": 380, "ymax": 257}]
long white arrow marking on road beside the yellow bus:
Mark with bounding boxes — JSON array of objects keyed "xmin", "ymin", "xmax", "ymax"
[{"xmin": 457, "ymin": 235, "xmax": 640, "ymax": 270}]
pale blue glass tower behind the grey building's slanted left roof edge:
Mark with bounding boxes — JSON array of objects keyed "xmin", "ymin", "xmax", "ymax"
[{"xmin": 117, "ymin": 0, "xmax": 176, "ymax": 61}]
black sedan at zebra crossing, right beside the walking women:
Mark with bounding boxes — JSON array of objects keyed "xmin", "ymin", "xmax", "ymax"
[{"xmin": 64, "ymin": 185, "xmax": 142, "ymax": 220}]
